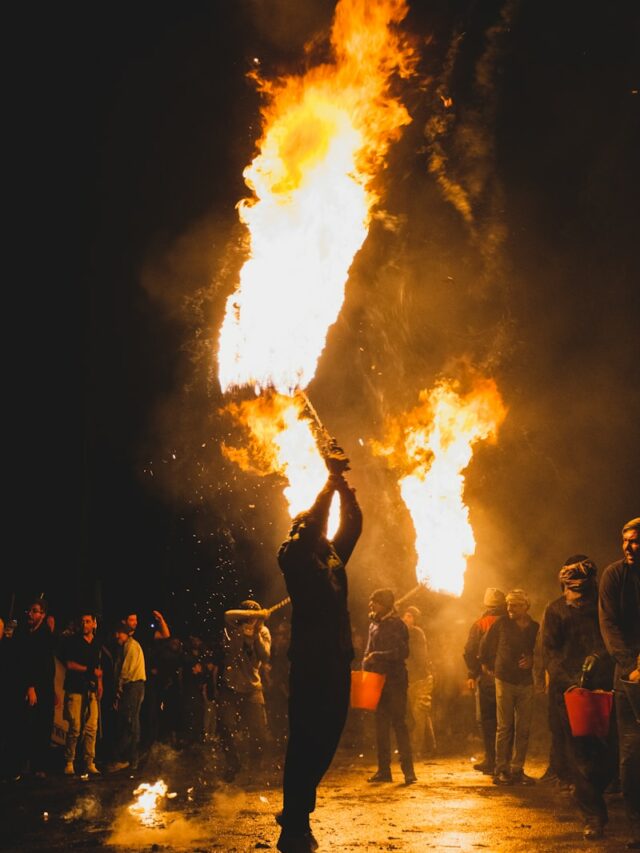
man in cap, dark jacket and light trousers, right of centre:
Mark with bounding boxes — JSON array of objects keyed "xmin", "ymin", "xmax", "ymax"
[{"xmin": 478, "ymin": 589, "xmax": 539, "ymax": 785}]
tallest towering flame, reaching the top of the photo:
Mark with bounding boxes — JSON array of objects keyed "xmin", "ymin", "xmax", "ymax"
[{"xmin": 218, "ymin": 0, "xmax": 415, "ymax": 394}]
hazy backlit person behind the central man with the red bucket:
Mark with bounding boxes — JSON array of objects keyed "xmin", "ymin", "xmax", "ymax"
[{"xmin": 402, "ymin": 605, "xmax": 436, "ymax": 757}]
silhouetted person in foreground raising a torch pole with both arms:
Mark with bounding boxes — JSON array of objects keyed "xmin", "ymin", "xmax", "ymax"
[{"xmin": 276, "ymin": 446, "xmax": 362, "ymax": 853}]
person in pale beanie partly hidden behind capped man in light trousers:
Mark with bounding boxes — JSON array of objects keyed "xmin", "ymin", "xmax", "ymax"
[{"xmin": 462, "ymin": 587, "xmax": 507, "ymax": 776}]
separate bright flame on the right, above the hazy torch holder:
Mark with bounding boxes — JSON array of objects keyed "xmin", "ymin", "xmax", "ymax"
[{"xmin": 373, "ymin": 379, "xmax": 507, "ymax": 595}]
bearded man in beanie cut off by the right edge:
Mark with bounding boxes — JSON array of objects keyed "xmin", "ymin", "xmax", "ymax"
[{"xmin": 599, "ymin": 518, "xmax": 640, "ymax": 850}]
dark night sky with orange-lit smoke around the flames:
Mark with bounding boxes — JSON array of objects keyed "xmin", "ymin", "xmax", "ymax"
[{"xmin": 7, "ymin": 0, "xmax": 640, "ymax": 632}]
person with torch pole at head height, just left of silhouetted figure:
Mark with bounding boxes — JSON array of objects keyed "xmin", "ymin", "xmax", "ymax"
[{"xmin": 218, "ymin": 598, "xmax": 271, "ymax": 782}]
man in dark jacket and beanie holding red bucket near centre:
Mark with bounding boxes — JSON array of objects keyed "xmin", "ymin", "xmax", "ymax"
[{"xmin": 362, "ymin": 589, "xmax": 417, "ymax": 785}]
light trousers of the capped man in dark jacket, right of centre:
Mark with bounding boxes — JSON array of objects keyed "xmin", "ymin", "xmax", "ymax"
[{"xmin": 496, "ymin": 678, "xmax": 533, "ymax": 775}]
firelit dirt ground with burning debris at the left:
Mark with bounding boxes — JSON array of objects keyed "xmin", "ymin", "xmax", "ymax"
[{"xmin": 0, "ymin": 744, "xmax": 626, "ymax": 853}]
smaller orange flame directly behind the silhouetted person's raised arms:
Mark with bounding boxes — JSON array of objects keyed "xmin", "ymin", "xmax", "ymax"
[{"xmin": 222, "ymin": 393, "xmax": 340, "ymax": 535}]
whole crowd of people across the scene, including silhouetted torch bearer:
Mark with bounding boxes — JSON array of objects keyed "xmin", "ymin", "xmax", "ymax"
[{"xmin": 0, "ymin": 506, "xmax": 640, "ymax": 853}]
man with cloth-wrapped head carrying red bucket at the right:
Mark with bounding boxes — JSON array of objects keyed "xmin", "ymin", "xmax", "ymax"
[{"xmin": 542, "ymin": 554, "xmax": 615, "ymax": 840}]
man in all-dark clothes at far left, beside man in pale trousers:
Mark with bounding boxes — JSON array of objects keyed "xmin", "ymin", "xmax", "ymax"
[{"xmin": 15, "ymin": 598, "xmax": 55, "ymax": 778}]
